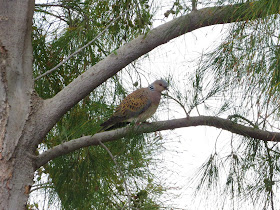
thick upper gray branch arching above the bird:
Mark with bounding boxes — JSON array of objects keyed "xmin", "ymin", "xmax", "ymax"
[{"xmin": 37, "ymin": 2, "xmax": 279, "ymax": 144}]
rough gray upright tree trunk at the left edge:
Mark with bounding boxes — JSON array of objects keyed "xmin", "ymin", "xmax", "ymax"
[{"xmin": 0, "ymin": 0, "xmax": 34, "ymax": 210}]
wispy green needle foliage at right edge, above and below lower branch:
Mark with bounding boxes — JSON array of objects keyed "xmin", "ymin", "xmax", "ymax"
[{"xmin": 189, "ymin": 0, "xmax": 280, "ymax": 209}]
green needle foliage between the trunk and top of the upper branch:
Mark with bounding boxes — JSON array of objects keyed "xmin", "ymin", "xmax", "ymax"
[{"xmin": 33, "ymin": 0, "xmax": 152, "ymax": 98}]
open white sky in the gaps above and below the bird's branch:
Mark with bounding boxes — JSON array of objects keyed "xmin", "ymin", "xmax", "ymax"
[{"xmin": 141, "ymin": 0, "xmax": 277, "ymax": 210}]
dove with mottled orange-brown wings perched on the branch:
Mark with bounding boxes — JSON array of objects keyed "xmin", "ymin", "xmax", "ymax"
[{"xmin": 99, "ymin": 79, "xmax": 168, "ymax": 132}]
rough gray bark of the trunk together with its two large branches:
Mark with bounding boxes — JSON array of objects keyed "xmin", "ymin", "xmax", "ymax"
[{"xmin": 0, "ymin": 0, "xmax": 280, "ymax": 210}]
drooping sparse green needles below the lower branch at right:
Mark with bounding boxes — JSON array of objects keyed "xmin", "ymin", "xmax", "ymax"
[{"xmin": 194, "ymin": 138, "xmax": 280, "ymax": 209}]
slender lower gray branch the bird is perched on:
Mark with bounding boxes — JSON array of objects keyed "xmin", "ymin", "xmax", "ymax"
[{"xmin": 36, "ymin": 116, "xmax": 280, "ymax": 168}]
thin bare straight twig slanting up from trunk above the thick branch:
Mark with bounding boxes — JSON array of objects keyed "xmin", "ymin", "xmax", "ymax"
[{"xmin": 34, "ymin": 14, "xmax": 123, "ymax": 81}]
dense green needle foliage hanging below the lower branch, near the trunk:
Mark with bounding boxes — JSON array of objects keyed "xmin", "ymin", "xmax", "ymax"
[{"xmin": 45, "ymin": 136, "xmax": 164, "ymax": 209}]
